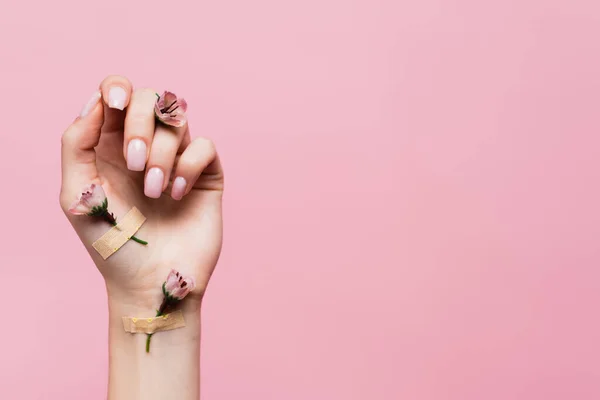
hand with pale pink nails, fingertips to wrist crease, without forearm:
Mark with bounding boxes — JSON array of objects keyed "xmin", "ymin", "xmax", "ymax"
[{"xmin": 60, "ymin": 76, "xmax": 223, "ymax": 313}]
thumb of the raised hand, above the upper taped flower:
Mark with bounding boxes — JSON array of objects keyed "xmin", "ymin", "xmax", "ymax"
[{"xmin": 60, "ymin": 91, "xmax": 104, "ymax": 210}]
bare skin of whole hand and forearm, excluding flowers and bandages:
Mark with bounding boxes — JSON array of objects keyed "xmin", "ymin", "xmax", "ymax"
[{"xmin": 60, "ymin": 76, "xmax": 223, "ymax": 400}]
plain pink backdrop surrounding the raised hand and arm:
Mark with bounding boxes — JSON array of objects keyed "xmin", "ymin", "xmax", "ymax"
[{"xmin": 0, "ymin": 0, "xmax": 600, "ymax": 400}]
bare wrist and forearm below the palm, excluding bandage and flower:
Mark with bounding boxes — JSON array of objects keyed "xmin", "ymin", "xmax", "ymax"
[{"xmin": 108, "ymin": 294, "xmax": 201, "ymax": 400}]
